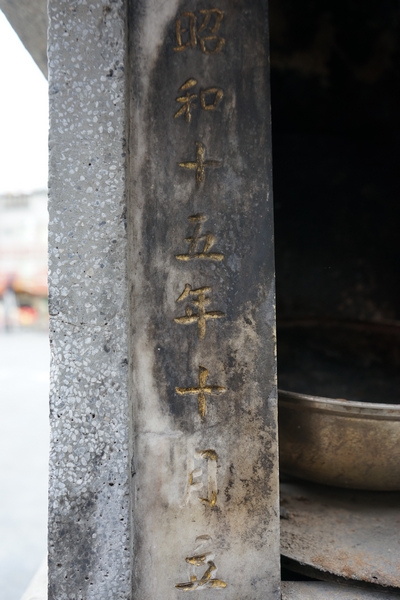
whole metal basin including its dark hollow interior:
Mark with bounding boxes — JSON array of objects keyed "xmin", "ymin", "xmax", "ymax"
[{"xmin": 278, "ymin": 320, "xmax": 400, "ymax": 490}]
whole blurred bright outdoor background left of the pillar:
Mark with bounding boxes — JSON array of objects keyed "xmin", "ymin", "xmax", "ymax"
[{"xmin": 0, "ymin": 12, "xmax": 49, "ymax": 600}]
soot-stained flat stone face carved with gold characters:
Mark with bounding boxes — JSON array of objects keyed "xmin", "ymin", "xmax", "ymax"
[{"xmin": 128, "ymin": 0, "xmax": 279, "ymax": 600}]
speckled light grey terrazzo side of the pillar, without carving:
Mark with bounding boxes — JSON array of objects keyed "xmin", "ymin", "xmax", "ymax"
[{"xmin": 48, "ymin": 0, "xmax": 132, "ymax": 600}]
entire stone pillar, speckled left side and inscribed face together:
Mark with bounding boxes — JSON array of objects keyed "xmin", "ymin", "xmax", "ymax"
[{"xmin": 49, "ymin": 0, "xmax": 279, "ymax": 600}]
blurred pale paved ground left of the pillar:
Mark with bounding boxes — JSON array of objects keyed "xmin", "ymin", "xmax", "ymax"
[{"xmin": 0, "ymin": 330, "xmax": 49, "ymax": 600}]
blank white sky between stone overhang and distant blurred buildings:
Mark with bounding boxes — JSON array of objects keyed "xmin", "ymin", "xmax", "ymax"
[{"xmin": 0, "ymin": 11, "xmax": 48, "ymax": 194}]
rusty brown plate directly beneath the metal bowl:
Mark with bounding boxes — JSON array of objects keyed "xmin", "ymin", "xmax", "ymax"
[{"xmin": 281, "ymin": 482, "xmax": 400, "ymax": 588}]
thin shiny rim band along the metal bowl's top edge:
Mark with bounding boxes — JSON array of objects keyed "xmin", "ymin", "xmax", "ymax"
[{"xmin": 278, "ymin": 389, "xmax": 400, "ymax": 421}]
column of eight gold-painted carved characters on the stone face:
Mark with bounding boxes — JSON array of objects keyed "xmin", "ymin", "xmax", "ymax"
[{"xmin": 170, "ymin": 8, "xmax": 228, "ymax": 591}]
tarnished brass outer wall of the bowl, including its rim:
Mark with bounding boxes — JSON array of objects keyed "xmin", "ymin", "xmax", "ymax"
[{"xmin": 278, "ymin": 391, "xmax": 400, "ymax": 491}]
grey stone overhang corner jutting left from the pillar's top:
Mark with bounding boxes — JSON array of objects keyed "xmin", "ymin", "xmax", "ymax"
[{"xmin": 0, "ymin": 0, "xmax": 47, "ymax": 77}]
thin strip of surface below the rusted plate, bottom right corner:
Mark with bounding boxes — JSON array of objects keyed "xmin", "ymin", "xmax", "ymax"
[{"xmin": 282, "ymin": 581, "xmax": 400, "ymax": 600}]
